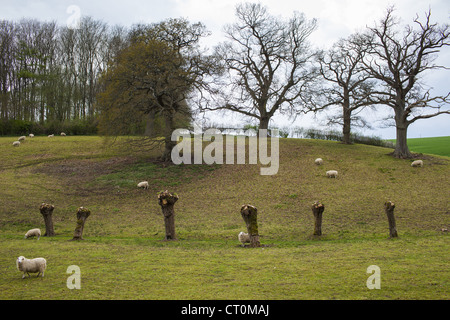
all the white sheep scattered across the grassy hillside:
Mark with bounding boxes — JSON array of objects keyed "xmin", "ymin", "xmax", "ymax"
[{"xmin": 13, "ymin": 139, "xmax": 423, "ymax": 279}]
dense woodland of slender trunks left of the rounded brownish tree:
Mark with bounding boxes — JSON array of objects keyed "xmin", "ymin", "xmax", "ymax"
[{"xmin": 0, "ymin": 17, "xmax": 126, "ymax": 134}]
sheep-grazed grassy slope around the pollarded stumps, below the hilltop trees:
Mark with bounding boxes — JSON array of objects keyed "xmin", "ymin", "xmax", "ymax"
[{"xmin": 0, "ymin": 137, "xmax": 450, "ymax": 300}]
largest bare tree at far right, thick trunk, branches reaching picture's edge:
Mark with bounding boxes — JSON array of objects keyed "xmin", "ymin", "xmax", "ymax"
[{"xmin": 364, "ymin": 8, "xmax": 450, "ymax": 158}]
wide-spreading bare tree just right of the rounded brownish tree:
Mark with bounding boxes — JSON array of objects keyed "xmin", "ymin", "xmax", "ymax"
[{"xmin": 203, "ymin": 3, "xmax": 317, "ymax": 129}]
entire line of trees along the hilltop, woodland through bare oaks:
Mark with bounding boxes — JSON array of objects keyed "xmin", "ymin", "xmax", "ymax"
[{"xmin": 0, "ymin": 3, "xmax": 450, "ymax": 160}]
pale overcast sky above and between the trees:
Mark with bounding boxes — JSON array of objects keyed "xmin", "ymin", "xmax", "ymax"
[{"xmin": 0, "ymin": 0, "xmax": 450, "ymax": 138}]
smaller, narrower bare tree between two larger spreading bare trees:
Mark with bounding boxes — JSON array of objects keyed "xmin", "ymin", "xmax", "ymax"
[{"xmin": 318, "ymin": 34, "xmax": 374, "ymax": 144}]
